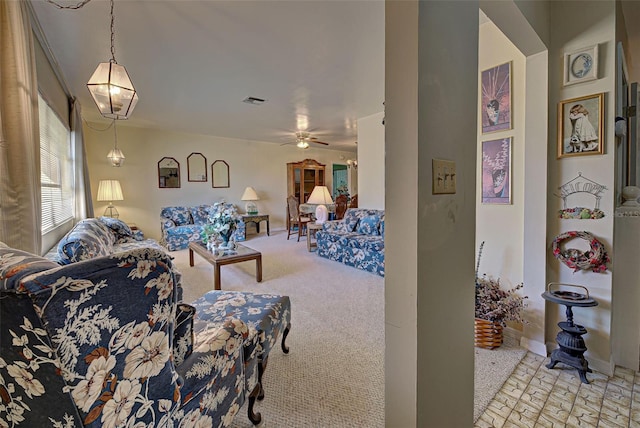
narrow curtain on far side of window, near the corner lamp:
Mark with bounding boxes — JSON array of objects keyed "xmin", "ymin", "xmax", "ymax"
[{"xmin": 71, "ymin": 99, "xmax": 93, "ymax": 220}]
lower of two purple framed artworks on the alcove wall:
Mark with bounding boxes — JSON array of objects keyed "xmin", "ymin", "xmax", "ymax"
[{"xmin": 482, "ymin": 137, "xmax": 513, "ymax": 205}]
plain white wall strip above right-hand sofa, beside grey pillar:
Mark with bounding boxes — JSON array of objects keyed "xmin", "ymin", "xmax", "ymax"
[{"xmin": 357, "ymin": 112, "xmax": 385, "ymax": 210}]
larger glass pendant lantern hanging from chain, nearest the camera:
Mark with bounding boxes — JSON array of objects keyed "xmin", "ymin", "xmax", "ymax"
[{"xmin": 87, "ymin": 0, "xmax": 138, "ymax": 119}]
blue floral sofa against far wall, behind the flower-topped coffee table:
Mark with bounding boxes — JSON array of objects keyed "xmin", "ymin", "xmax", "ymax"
[{"xmin": 160, "ymin": 202, "xmax": 245, "ymax": 251}]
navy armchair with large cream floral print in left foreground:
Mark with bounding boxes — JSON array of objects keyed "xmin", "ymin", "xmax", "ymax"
[{"xmin": 0, "ymin": 245, "xmax": 257, "ymax": 427}]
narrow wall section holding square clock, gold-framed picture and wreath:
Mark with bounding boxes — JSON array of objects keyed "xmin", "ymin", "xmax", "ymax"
[{"xmin": 546, "ymin": 1, "xmax": 616, "ymax": 374}]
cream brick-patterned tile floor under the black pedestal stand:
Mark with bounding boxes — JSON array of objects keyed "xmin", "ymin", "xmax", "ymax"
[{"xmin": 475, "ymin": 352, "xmax": 640, "ymax": 428}]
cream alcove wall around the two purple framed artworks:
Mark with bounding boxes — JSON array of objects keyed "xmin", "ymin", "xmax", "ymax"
[{"xmin": 476, "ymin": 22, "xmax": 528, "ymax": 288}]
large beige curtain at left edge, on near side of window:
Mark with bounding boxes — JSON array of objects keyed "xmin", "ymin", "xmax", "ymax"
[{"xmin": 0, "ymin": 0, "xmax": 42, "ymax": 254}]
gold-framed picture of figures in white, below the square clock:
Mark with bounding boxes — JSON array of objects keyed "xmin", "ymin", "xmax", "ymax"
[{"xmin": 558, "ymin": 93, "xmax": 604, "ymax": 159}]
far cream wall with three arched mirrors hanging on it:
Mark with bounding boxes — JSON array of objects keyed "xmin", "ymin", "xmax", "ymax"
[{"xmin": 84, "ymin": 123, "xmax": 353, "ymax": 244}]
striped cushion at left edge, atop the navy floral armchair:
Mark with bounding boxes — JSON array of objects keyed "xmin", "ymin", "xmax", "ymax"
[{"xmin": 0, "ymin": 242, "xmax": 58, "ymax": 290}]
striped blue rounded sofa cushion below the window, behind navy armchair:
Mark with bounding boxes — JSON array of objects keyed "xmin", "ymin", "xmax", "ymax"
[{"xmin": 58, "ymin": 218, "xmax": 115, "ymax": 264}]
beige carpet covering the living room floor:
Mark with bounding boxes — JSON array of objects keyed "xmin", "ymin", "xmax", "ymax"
[{"xmin": 171, "ymin": 230, "xmax": 524, "ymax": 428}]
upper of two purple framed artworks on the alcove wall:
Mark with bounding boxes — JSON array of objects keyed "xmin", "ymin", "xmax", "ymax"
[{"xmin": 480, "ymin": 62, "xmax": 511, "ymax": 134}]
